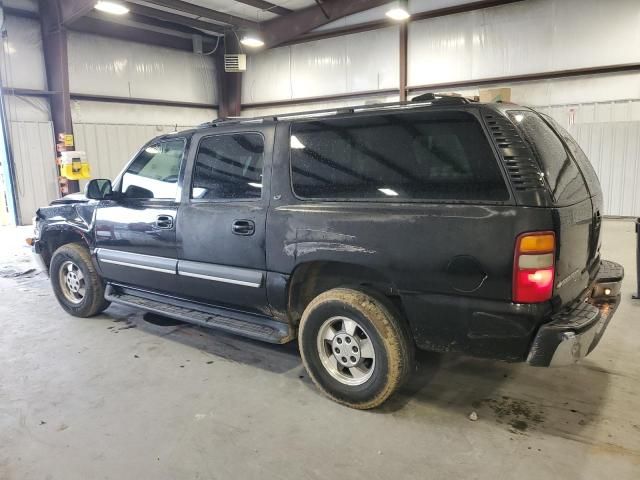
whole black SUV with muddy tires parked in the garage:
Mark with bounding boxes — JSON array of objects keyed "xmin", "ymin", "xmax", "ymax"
[{"xmin": 33, "ymin": 96, "xmax": 623, "ymax": 409}]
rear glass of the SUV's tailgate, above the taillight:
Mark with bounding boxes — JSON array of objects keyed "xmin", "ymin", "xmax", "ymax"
[{"xmin": 509, "ymin": 111, "xmax": 589, "ymax": 206}]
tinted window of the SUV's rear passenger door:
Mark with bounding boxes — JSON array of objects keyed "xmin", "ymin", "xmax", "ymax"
[{"xmin": 191, "ymin": 133, "xmax": 264, "ymax": 200}]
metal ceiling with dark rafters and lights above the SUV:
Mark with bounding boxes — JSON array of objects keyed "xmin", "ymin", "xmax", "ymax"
[{"xmin": 52, "ymin": 0, "xmax": 390, "ymax": 48}]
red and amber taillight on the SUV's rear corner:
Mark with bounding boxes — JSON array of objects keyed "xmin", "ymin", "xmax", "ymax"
[{"xmin": 513, "ymin": 232, "xmax": 556, "ymax": 303}]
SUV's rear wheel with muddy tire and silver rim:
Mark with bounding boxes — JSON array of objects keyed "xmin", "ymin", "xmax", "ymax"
[{"xmin": 298, "ymin": 288, "xmax": 414, "ymax": 410}]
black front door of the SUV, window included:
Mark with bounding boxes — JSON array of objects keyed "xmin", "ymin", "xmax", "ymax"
[{"xmin": 95, "ymin": 138, "xmax": 187, "ymax": 292}]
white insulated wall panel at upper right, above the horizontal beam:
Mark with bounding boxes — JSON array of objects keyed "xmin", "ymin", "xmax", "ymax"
[{"xmin": 408, "ymin": 0, "xmax": 640, "ymax": 85}]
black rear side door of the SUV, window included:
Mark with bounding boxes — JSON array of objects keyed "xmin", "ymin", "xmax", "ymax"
[{"xmin": 177, "ymin": 129, "xmax": 273, "ymax": 313}]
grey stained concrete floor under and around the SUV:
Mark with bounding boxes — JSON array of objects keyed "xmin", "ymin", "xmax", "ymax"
[{"xmin": 0, "ymin": 220, "xmax": 640, "ymax": 480}]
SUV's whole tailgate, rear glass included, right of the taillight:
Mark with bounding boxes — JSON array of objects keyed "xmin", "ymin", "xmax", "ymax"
[{"xmin": 509, "ymin": 110, "xmax": 599, "ymax": 304}]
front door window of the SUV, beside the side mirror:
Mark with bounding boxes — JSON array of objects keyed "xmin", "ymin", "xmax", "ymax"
[{"xmin": 121, "ymin": 139, "xmax": 185, "ymax": 199}]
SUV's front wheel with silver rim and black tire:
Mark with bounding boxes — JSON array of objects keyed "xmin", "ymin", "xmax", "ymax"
[{"xmin": 49, "ymin": 243, "xmax": 109, "ymax": 318}]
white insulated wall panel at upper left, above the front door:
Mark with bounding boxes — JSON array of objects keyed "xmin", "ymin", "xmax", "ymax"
[{"xmin": 68, "ymin": 32, "xmax": 216, "ymax": 105}]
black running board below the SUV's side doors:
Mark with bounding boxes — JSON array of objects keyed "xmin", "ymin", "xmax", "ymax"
[{"xmin": 104, "ymin": 284, "xmax": 295, "ymax": 343}]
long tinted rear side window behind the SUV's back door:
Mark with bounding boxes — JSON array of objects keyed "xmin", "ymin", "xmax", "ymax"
[{"xmin": 291, "ymin": 112, "xmax": 509, "ymax": 200}]
